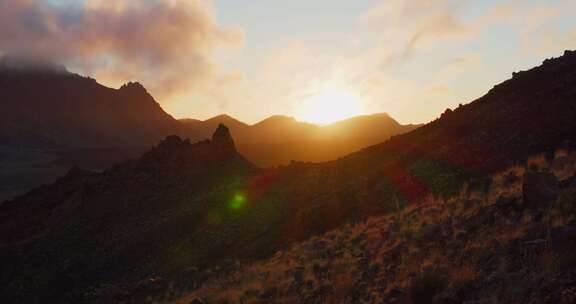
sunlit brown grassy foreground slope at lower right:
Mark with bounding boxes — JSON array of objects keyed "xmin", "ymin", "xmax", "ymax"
[{"xmin": 180, "ymin": 151, "xmax": 576, "ymax": 304}]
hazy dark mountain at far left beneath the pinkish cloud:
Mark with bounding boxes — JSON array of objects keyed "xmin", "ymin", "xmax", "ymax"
[{"xmin": 0, "ymin": 57, "xmax": 189, "ymax": 201}]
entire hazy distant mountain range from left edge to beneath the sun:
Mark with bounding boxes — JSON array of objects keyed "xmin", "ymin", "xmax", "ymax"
[{"xmin": 0, "ymin": 57, "xmax": 412, "ymax": 201}]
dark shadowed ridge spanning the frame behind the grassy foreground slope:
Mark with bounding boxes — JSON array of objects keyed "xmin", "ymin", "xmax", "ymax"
[{"xmin": 0, "ymin": 51, "xmax": 576, "ymax": 303}]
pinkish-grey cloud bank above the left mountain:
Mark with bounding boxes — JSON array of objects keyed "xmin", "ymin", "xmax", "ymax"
[{"xmin": 0, "ymin": 0, "xmax": 243, "ymax": 97}]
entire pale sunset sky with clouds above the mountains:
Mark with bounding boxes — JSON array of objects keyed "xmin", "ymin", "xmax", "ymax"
[{"xmin": 0, "ymin": 0, "xmax": 576, "ymax": 123}]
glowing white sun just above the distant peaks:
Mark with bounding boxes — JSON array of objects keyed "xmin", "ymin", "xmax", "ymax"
[{"xmin": 297, "ymin": 88, "xmax": 364, "ymax": 125}]
